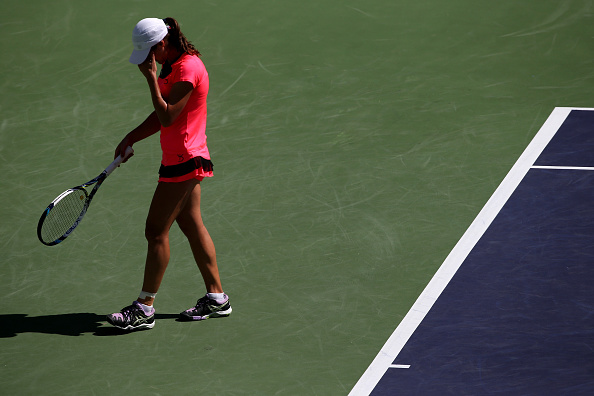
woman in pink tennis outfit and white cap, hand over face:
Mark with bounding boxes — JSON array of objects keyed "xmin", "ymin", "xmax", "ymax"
[{"xmin": 107, "ymin": 18, "xmax": 231, "ymax": 330}]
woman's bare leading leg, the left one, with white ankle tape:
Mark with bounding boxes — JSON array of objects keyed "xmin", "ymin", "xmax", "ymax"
[{"xmin": 138, "ymin": 180, "xmax": 195, "ymax": 305}]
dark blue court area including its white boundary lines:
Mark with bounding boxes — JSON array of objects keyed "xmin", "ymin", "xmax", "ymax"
[{"xmin": 351, "ymin": 108, "xmax": 594, "ymax": 395}]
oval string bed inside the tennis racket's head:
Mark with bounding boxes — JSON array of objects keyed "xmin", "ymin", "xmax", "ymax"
[{"xmin": 41, "ymin": 190, "xmax": 87, "ymax": 243}]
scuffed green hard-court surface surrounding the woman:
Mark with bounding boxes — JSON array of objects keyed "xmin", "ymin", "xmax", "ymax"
[{"xmin": 0, "ymin": 0, "xmax": 594, "ymax": 395}]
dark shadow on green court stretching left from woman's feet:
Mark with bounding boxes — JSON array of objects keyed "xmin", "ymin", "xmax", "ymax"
[{"xmin": 0, "ymin": 313, "xmax": 178, "ymax": 338}]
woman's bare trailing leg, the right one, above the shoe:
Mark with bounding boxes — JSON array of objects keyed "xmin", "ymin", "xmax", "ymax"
[{"xmin": 177, "ymin": 183, "xmax": 223, "ymax": 293}]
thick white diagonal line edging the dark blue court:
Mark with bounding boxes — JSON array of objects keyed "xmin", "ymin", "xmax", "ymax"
[{"xmin": 349, "ymin": 107, "xmax": 594, "ymax": 396}]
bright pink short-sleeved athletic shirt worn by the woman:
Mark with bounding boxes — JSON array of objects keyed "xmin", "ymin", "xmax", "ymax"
[{"xmin": 158, "ymin": 54, "xmax": 210, "ymax": 166}]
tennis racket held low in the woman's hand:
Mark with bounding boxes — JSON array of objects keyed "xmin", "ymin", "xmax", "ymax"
[{"xmin": 37, "ymin": 147, "xmax": 134, "ymax": 246}]
